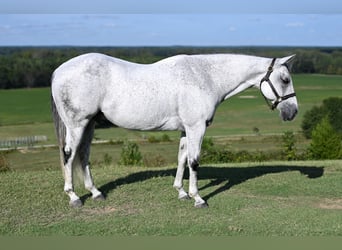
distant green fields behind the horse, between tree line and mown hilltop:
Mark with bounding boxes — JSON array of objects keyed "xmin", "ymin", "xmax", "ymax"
[{"xmin": 0, "ymin": 75, "xmax": 342, "ymax": 170}]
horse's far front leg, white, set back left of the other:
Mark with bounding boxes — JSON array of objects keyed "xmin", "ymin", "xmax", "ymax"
[{"xmin": 173, "ymin": 132, "xmax": 190, "ymax": 200}]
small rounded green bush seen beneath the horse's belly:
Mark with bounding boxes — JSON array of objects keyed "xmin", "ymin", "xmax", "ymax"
[{"xmin": 119, "ymin": 142, "xmax": 142, "ymax": 165}]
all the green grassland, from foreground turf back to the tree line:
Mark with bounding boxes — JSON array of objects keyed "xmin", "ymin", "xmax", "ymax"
[{"xmin": 0, "ymin": 75, "xmax": 342, "ymax": 236}]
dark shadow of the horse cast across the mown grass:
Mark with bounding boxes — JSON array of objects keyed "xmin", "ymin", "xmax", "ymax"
[{"xmin": 81, "ymin": 165, "xmax": 324, "ymax": 202}]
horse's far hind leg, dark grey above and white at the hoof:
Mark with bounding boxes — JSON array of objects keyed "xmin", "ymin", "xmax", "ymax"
[{"xmin": 78, "ymin": 120, "xmax": 105, "ymax": 201}]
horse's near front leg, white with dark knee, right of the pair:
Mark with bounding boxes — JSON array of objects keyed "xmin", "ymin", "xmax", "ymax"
[{"xmin": 186, "ymin": 123, "xmax": 208, "ymax": 208}]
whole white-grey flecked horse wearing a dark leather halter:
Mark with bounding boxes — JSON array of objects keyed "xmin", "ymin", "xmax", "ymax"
[{"xmin": 51, "ymin": 53, "xmax": 298, "ymax": 207}]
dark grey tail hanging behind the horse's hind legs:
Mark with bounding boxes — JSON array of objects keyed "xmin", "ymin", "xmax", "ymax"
[{"xmin": 51, "ymin": 94, "xmax": 67, "ymax": 174}]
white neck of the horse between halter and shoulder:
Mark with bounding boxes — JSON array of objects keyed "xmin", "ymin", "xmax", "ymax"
[{"xmin": 198, "ymin": 54, "xmax": 271, "ymax": 102}]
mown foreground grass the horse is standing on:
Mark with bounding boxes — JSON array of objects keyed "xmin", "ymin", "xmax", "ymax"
[{"xmin": 0, "ymin": 161, "xmax": 342, "ymax": 236}]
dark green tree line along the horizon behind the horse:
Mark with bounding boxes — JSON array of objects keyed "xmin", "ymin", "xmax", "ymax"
[{"xmin": 0, "ymin": 46, "xmax": 342, "ymax": 89}]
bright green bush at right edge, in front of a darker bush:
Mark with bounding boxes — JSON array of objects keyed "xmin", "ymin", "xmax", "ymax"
[{"xmin": 308, "ymin": 117, "xmax": 342, "ymax": 160}]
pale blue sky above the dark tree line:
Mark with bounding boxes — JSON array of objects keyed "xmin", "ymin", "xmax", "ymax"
[{"xmin": 0, "ymin": 0, "xmax": 342, "ymax": 46}]
